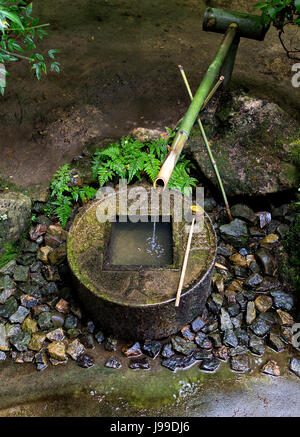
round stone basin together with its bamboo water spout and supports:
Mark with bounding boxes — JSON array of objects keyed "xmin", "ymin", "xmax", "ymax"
[{"xmin": 68, "ymin": 8, "xmax": 268, "ymax": 339}]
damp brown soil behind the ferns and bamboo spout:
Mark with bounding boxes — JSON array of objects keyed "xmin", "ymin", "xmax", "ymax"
[{"xmin": 0, "ymin": 0, "xmax": 300, "ymax": 188}]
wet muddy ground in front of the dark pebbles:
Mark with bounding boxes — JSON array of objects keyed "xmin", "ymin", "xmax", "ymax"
[{"xmin": 0, "ymin": 340, "xmax": 300, "ymax": 417}]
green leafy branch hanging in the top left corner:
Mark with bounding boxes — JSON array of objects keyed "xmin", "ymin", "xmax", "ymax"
[{"xmin": 0, "ymin": 0, "xmax": 60, "ymax": 95}]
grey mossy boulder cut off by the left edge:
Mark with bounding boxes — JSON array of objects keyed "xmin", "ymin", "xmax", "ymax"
[{"xmin": 0, "ymin": 191, "xmax": 31, "ymax": 255}]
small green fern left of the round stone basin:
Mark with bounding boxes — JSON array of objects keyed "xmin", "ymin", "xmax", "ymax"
[{"xmin": 44, "ymin": 164, "xmax": 96, "ymax": 228}]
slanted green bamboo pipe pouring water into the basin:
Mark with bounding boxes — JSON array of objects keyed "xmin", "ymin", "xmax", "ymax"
[{"xmin": 154, "ymin": 23, "xmax": 238, "ymax": 189}]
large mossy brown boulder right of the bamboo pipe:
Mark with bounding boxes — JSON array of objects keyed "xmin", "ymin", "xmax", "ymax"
[{"xmin": 186, "ymin": 93, "xmax": 300, "ymax": 196}]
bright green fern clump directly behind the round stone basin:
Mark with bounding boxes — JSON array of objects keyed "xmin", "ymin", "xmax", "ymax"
[{"xmin": 92, "ymin": 135, "xmax": 197, "ymax": 193}]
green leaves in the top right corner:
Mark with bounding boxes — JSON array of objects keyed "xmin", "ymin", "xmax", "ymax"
[{"xmin": 254, "ymin": 0, "xmax": 300, "ymax": 59}]
